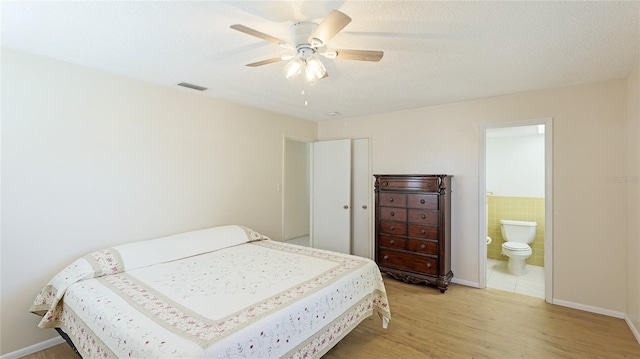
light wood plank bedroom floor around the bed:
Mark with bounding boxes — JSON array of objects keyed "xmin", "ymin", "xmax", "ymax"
[{"xmin": 25, "ymin": 277, "xmax": 640, "ymax": 359}]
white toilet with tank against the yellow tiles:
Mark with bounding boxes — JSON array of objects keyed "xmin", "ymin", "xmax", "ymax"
[{"xmin": 500, "ymin": 219, "xmax": 538, "ymax": 276}]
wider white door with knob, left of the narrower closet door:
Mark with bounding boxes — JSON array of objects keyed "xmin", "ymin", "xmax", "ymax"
[{"xmin": 312, "ymin": 140, "xmax": 351, "ymax": 254}]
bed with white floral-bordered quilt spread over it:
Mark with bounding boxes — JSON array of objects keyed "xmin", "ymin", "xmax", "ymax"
[{"xmin": 31, "ymin": 225, "xmax": 391, "ymax": 359}]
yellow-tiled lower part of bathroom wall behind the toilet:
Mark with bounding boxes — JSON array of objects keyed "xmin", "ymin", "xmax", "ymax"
[{"xmin": 487, "ymin": 195, "xmax": 544, "ymax": 266}]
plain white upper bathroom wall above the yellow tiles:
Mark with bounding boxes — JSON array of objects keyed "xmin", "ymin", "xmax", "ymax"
[{"xmin": 486, "ymin": 126, "xmax": 545, "ymax": 197}]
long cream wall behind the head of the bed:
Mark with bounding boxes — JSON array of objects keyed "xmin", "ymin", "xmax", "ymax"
[{"xmin": 0, "ymin": 49, "xmax": 317, "ymax": 354}]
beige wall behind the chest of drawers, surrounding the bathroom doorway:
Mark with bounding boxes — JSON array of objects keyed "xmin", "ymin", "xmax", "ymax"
[{"xmin": 318, "ymin": 81, "xmax": 637, "ymax": 313}]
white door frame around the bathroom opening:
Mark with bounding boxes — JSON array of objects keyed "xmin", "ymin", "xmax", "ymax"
[{"xmin": 478, "ymin": 117, "xmax": 553, "ymax": 303}]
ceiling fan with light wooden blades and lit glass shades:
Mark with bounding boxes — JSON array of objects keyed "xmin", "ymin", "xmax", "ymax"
[{"xmin": 231, "ymin": 10, "xmax": 384, "ymax": 81}]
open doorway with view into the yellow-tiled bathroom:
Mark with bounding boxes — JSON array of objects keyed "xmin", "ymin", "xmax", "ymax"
[{"xmin": 479, "ymin": 118, "xmax": 553, "ymax": 303}]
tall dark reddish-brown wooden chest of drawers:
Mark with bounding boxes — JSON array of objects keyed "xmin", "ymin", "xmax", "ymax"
[{"xmin": 374, "ymin": 175, "xmax": 453, "ymax": 293}]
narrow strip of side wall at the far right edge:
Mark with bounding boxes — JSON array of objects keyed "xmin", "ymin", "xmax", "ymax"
[{"xmin": 619, "ymin": 65, "xmax": 640, "ymax": 342}]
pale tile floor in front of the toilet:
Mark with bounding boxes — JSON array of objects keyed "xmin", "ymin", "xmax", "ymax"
[{"xmin": 487, "ymin": 258, "xmax": 544, "ymax": 299}]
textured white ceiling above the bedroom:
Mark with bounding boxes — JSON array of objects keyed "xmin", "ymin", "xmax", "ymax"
[{"xmin": 2, "ymin": 1, "xmax": 640, "ymax": 121}]
